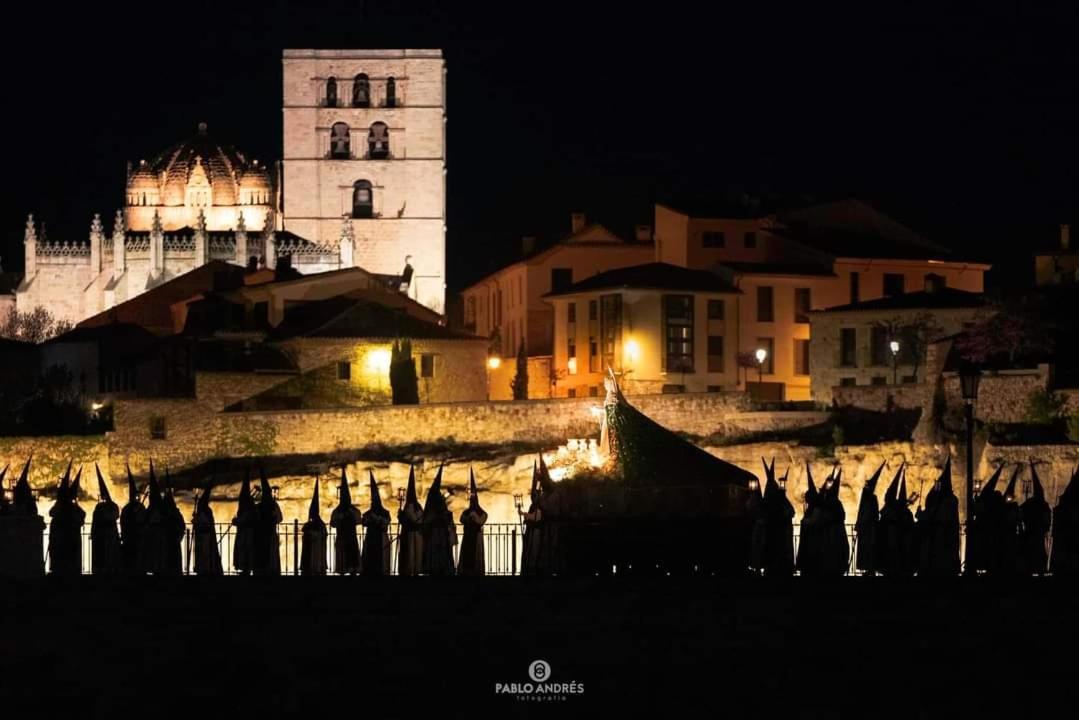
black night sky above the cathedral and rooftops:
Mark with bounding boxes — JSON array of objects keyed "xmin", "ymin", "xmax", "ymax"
[{"xmin": 0, "ymin": 0, "xmax": 1079, "ymax": 288}]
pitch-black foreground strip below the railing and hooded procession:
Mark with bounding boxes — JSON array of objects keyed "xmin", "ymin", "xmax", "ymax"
[{"xmin": 0, "ymin": 578, "xmax": 1079, "ymax": 720}]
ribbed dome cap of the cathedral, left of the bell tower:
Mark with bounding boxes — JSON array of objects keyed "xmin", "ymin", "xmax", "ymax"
[{"xmin": 149, "ymin": 123, "xmax": 247, "ymax": 205}]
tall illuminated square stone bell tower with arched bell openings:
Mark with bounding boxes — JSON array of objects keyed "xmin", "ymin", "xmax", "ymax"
[{"xmin": 282, "ymin": 50, "xmax": 446, "ymax": 312}]
